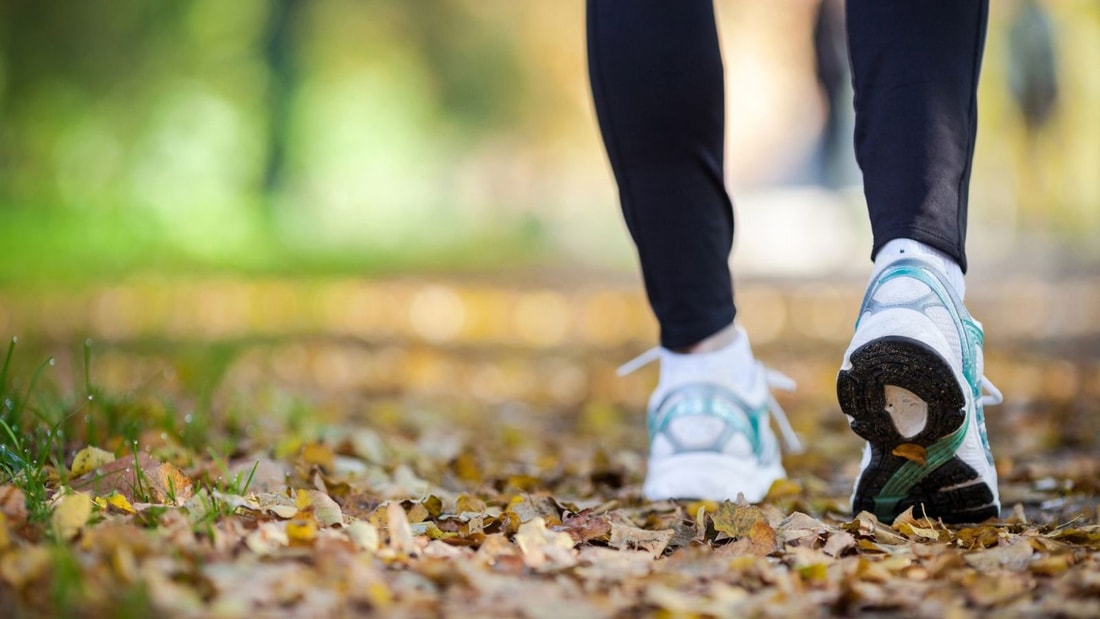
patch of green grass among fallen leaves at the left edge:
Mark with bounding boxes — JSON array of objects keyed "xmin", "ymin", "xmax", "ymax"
[{"xmin": 0, "ymin": 338, "xmax": 268, "ymax": 538}]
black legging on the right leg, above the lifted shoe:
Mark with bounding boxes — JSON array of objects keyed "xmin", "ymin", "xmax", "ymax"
[{"xmin": 847, "ymin": 0, "xmax": 989, "ymax": 272}]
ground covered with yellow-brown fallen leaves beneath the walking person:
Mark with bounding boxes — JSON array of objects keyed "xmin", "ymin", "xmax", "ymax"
[{"xmin": 0, "ymin": 277, "xmax": 1100, "ymax": 618}]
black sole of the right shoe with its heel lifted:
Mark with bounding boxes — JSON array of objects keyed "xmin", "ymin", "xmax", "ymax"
[{"xmin": 836, "ymin": 335, "xmax": 999, "ymax": 523}]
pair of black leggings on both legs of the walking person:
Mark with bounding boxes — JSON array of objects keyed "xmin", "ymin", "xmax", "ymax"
[{"xmin": 587, "ymin": 0, "xmax": 989, "ymax": 349}]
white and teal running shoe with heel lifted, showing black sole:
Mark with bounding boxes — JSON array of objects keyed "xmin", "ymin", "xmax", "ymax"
[{"xmin": 836, "ymin": 258, "xmax": 1001, "ymax": 522}]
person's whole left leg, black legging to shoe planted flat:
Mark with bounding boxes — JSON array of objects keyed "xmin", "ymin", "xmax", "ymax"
[{"xmin": 587, "ymin": 0, "xmax": 793, "ymax": 500}]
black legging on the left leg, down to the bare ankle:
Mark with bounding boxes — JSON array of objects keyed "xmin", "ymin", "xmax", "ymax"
[{"xmin": 587, "ymin": 0, "xmax": 734, "ymax": 350}]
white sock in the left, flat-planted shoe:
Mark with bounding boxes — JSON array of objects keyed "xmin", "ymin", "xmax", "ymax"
[{"xmin": 653, "ymin": 324, "xmax": 756, "ymax": 399}]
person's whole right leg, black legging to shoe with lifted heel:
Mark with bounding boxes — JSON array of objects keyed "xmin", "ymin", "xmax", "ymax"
[{"xmin": 837, "ymin": 0, "xmax": 1000, "ymax": 522}]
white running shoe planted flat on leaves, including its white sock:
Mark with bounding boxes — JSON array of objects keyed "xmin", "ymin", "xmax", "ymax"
[{"xmin": 619, "ymin": 327, "xmax": 801, "ymax": 501}]
